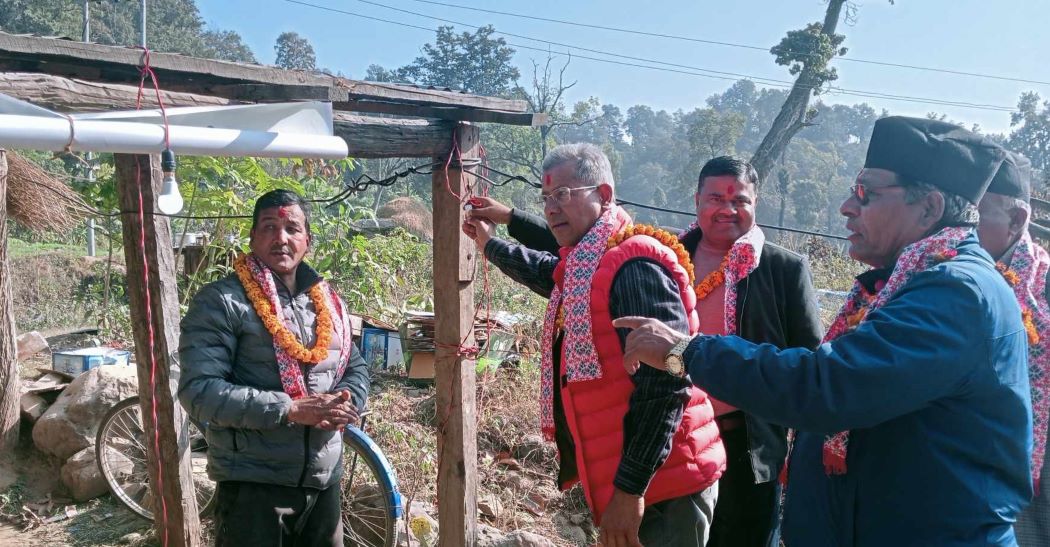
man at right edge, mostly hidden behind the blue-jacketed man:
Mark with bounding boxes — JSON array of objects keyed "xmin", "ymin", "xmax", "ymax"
[{"xmin": 978, "ymin": 153, "xmax": 1050, "ymax": 547}]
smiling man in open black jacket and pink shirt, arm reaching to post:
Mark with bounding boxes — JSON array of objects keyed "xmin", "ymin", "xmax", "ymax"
[{"xmin": 470, "ymin": 156, "xmax": 823, "ymax": 547}]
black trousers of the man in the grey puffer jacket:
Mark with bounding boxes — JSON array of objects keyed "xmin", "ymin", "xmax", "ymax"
[{"xmin": 215, "ymin": 481, "xmax": 342, "ymax": 547}]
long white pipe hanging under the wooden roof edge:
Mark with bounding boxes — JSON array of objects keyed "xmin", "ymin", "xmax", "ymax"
[{"xmin": 0, "ymin": 114, "xmax": 348, "ymax": 160}]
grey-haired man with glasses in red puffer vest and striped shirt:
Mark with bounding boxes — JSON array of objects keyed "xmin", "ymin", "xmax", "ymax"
[{"xmin": 464, "ymin": 144, "xmax": 726, "ymax": 546}]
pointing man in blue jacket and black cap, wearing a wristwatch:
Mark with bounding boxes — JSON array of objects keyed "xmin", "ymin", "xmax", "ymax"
[{"xmin": 614, "ymin": 117, "xmax": 1032, "ymax": 547}]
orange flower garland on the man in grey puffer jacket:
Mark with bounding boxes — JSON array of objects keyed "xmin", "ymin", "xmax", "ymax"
[{"xmin": 233, "ymin": 255, "xmax": 333, "ymax": 364}]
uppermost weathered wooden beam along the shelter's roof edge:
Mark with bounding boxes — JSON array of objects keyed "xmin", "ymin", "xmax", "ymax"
[{"xmin": 0, "ymin": 33, "xmax": 528, "ymax": 113}]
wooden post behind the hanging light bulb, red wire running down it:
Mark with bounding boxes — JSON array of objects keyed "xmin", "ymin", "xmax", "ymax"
[{"xmin": 113, "ymin": 154, "xmax": 201, "ymax": 547}]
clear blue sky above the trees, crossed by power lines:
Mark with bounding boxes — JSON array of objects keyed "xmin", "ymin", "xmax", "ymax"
[{"xmin": 198, "ymin": 0, "xmax": 1050, "ymax": 132}]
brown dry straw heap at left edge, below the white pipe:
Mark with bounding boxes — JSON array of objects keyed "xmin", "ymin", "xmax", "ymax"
[{"xmin": 7, "ymin": 150, "xmax": 87, "ymax": 232}]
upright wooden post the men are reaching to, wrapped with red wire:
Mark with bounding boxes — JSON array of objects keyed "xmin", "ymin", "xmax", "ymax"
[{"xmin": 432, "ymin": 124, "xmax": 480, "ymax": 546}]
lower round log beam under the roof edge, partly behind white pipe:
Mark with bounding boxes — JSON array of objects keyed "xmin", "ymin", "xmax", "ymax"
[{"xmin": 0, "ymin": 72, "xmax": 459, "ymax": 157}]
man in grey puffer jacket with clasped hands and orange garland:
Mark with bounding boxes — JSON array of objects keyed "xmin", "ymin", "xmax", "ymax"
[{"xmin": 179, "ymin": 190, "xmax": 370, "ymax": 546}]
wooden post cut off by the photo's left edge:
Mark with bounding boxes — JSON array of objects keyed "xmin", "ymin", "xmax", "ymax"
[{"xmin": 0, "ymin": 148, "xmax": 21, "ymax": 454}]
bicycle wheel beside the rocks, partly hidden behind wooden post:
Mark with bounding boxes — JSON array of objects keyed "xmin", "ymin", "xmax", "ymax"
[{"xmin": 95, "ymin": 397, "xmax": 215, "ymax": 521}]
